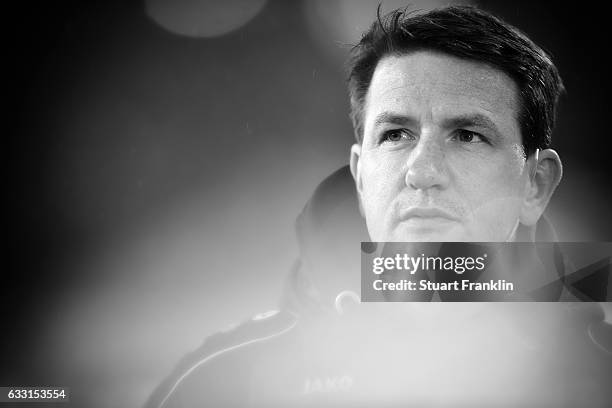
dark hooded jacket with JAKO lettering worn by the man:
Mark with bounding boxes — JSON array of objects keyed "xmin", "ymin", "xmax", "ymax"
[{"xmin": 146, "ymin": 167, "xmax": 612, "ymax": 407}]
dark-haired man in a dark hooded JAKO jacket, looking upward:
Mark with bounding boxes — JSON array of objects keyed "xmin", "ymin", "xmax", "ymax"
[{"xmin": 148, "ymin": 7, "xmax": 612, "ymax": 407}]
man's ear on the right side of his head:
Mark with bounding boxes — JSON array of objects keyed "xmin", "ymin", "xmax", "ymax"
[{"xmin": 520, "ymin": 149, "xmax": 563, "ymax": 226}]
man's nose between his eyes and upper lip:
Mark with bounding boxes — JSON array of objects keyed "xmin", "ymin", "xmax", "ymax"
[{"xmin": 406, "ymin": 135, "xmax": 449, "ymax": 190}]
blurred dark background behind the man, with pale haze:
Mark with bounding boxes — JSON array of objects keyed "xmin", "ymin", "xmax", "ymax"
[{"xmin": 0, "ymin": 0, "xmax": 612, "ymax": 407}]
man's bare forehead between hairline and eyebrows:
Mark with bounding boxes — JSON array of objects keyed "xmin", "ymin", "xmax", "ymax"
[{"xmin": 364, "ymin": 51, "xmax": 519, "ymax": 132}]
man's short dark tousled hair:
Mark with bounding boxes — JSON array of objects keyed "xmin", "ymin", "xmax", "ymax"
[{"xmin": 348, "ymin": 6, "xmax": 564, "ymax": 156}]
